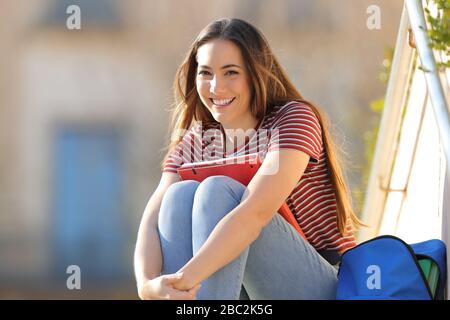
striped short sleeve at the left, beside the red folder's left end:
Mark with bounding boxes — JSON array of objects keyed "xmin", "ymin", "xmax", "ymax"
[{"xmin": 162, "ymin": 127, "xmax": 202, "ymax": 173}]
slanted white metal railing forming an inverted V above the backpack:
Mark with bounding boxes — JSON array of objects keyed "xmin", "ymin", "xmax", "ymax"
[{"xmin": 358, "ymin": 0, "xmax": 450, "ymax": 241}]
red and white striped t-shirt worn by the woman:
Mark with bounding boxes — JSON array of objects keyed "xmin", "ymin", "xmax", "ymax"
[{"xmin": 163, "ymin": 101, "xmax": 356, "ymax": 251}]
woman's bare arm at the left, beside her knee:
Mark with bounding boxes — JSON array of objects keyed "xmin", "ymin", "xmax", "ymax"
[{"xmin": 134, "ymin": 172, "xmax": 180, "ymax": 291}]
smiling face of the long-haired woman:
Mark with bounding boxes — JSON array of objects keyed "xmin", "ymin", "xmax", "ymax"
[{"xmin": 196, "ymin": 40, "xmax": 257, "ymax": 130}]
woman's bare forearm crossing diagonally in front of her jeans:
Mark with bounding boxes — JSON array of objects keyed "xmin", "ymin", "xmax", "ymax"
[{"xmin": 174, "ymin": 149, "xmax": 309, "ymax": 290}]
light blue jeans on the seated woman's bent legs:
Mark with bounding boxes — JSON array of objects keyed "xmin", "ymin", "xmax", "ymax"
[{"xmin": 158, "ymin": 176, "xmax": 337, "ymax": 300}]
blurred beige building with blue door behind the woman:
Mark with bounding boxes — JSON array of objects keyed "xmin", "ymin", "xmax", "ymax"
[{"xmin": 0, "ymin": 0, "xmax": 402, "ymax": 299}]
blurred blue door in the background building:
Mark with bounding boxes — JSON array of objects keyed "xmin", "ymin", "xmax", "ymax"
[{"xmin": 52, "ymin": 127, "xmax": 126, "ymax": 286}]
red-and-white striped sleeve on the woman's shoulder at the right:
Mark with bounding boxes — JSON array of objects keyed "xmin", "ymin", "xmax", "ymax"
[{"xmin": 268, "ymin": 103, "xmax": 323, "ymax": 163}]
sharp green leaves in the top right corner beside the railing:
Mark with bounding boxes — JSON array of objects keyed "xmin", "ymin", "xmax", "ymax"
[{"xmin": 425, "ymin": 0, "xmax": 450, "ymax": 70}]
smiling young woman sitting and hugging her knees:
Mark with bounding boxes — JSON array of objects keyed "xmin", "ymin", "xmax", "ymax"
[{"xmin": 134, "ymin": 19, "xmax": 362, "ymax": 299}]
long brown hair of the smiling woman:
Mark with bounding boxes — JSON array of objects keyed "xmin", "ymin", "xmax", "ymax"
[{"xmin": 161, "ymin": 19, "xmax": 365, "ymax": 235}]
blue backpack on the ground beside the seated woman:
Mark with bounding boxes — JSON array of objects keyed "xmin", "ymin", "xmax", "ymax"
[{"xmin": 336, "ymin": 235, "xmax": 447, "ymax": 300}]
